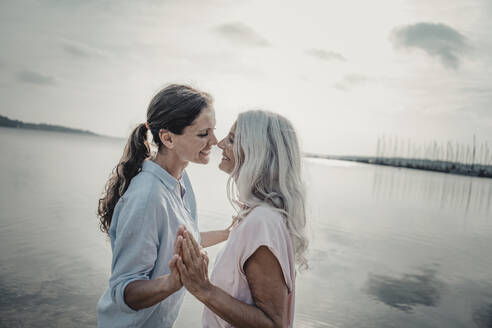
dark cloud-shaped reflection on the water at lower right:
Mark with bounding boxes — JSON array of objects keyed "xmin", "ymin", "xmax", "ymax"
[{"xmin": 367, "ymin": 269, "xmax": 444, "ymax": 312}]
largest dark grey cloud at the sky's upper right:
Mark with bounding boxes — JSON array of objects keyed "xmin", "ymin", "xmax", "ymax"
[{"xmin": 390, "ymin": 23, "xmax": 470, "ymax": 69}]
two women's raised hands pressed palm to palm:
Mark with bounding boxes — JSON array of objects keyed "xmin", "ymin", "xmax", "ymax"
[{"xmin": 169, "ymin": 226, "xmax": 211, "ymax": 300}]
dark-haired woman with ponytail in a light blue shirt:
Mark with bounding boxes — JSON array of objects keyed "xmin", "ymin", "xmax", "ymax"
[{"xmin": 97, "ymin": 85, "xmax": 228, "ymax": 327}]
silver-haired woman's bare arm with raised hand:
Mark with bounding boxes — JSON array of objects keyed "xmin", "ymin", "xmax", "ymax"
[{"xmin": 178, "ymin": 232, "xmax": 288, "ymax": 327}]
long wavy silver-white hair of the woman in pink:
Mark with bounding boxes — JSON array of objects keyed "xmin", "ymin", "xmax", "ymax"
[{"xmin": 227, "ymin": 110, "xmax": 308, "ymax": 270}]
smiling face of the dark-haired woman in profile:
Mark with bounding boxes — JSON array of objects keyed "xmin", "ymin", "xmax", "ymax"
[{"xmin": 174, "ymin": 107, "xmax": 217, "ymax": 164}]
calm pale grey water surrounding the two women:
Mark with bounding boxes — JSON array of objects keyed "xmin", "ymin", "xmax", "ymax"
[{"xmin": 0, "ymin": 128, "xmax": 492, "ymax": 328}]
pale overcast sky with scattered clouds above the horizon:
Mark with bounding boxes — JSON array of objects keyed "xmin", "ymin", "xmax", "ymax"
[{"xmin": 0, "ymin": 0, "xmax": 492, "ymax": 155}]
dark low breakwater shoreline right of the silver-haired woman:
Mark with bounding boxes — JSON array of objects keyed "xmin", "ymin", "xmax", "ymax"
[{"xmin": 304, "ymin": 154, "xmax": 492, "ymax": 178}]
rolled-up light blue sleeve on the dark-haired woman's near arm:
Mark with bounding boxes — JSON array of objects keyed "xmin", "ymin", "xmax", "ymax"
[{"xmin": 109, "ymin": 196, "xmax": 163, "ymax": 313}]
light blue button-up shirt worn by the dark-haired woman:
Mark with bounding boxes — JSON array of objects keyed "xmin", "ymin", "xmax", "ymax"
[{"xmin": 97, "ymin": 160, "xmax": 200, "ymax": 328}]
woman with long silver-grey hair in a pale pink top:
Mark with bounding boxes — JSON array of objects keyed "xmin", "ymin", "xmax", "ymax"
[{"xmin": 177, "ymin": 111, "xmax": 308, "ymax": 328}]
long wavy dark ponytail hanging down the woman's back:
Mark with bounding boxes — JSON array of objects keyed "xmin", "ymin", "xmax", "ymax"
[{"xmin": 97, "ymin": 123, "xmax": 150, "ymax": 235}]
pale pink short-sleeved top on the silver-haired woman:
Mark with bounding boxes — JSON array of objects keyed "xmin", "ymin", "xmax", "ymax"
[{"xmin": 202, "ymin": 205, "xmax": 295, "ymax": 328}]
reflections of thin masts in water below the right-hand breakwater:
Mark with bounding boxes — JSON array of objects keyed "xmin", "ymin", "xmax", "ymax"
[{"xmin": 372, "ymin": 166, "xmax": 492, "ymax": 214}]
